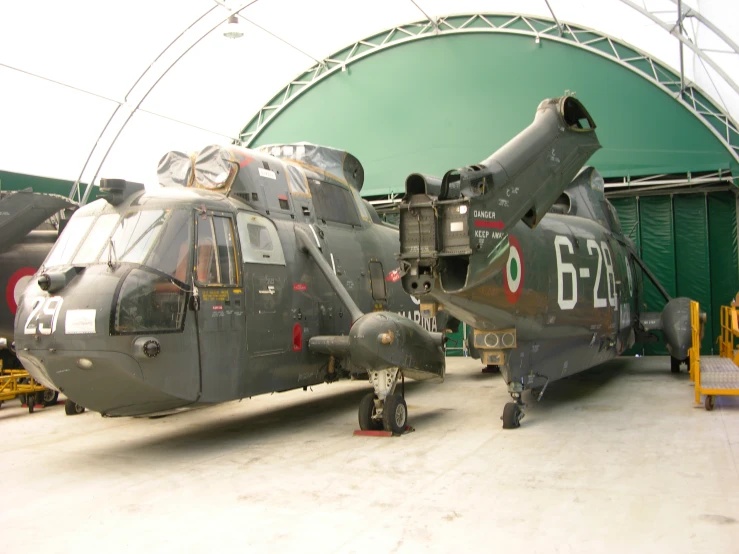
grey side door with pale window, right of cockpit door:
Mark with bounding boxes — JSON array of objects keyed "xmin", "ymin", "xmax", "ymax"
[{"xmin": 236, "ymin": 212, "xmax": 292, "ymax": 356}]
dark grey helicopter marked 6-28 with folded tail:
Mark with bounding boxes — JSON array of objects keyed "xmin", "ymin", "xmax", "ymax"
[{"xmin": 399, "ymin": 96, "xmax": 692, "ymax": 429}]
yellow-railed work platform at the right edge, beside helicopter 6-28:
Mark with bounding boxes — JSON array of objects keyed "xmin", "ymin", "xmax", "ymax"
[{"xmin": 690, "ymin": 302, "xmax": 739, "ymax": 411}]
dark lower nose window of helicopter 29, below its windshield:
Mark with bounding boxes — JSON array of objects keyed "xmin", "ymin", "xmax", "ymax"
[{"xmin": 113, "ymin": 268, "xmax": 189, "ymax": 334}]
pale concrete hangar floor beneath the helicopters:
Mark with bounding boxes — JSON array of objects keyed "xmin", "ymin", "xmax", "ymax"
[{"xmin": 0, "ymin": 358, "xmax": 739, "ymax": 554}]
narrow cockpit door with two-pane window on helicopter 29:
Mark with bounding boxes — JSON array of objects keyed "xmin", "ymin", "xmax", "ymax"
[{"xmin": 195, "ymin": 214, "xmax": 245, "ymax": 402}]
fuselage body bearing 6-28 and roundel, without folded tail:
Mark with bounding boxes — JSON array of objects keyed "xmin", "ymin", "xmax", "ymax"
[{"xmin": 430, "ymin": 209, "xmax": 641, "ymax": 386}]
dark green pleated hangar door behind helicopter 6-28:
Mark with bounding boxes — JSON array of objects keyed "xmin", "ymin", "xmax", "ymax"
[{"xmin": 611, "ymin": 191, "xmax": 739, "ymax": 355}]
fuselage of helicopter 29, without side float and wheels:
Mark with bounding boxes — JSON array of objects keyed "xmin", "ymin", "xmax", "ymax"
[{"xmin": 15, "ymin": 154, "xmax": 435, "ymax": 415}]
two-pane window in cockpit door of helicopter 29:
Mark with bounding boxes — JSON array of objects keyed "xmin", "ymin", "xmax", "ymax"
[{"xmin": 196, "ymin": 216, "xmax": 238, "ymax": 286}]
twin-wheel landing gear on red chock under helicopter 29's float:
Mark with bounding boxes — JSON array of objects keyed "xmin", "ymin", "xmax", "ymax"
[{"xmin": 359, "ymin": 368, "xmax": 408, "ymax": 435}]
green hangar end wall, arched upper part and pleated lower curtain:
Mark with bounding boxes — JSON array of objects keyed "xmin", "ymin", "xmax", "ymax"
[{"xmin": 242, "ymin": 22, "xmax": 739, "ymax": 354}]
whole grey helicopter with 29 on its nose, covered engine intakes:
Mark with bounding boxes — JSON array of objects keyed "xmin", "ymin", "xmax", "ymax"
[{"xmin": 15, "ymin": 143, "xmax": 445, "ymax": 434}]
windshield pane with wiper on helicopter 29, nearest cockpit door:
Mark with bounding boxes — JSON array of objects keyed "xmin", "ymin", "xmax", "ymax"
[{"xmin": 100, "ymin": 210, "xmax": 165, "ymax": 264}]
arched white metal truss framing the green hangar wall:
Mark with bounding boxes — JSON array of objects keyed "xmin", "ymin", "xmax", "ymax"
[{"xmin": 239, "ymin": 12, "xmax": 739, "ymax": 167}]
